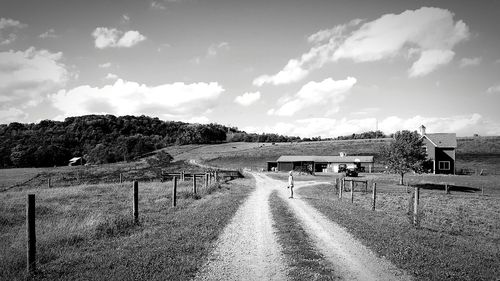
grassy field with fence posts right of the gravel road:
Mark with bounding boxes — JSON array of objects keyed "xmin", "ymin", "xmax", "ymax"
[{"xmin": 297, "ymin": 184, "xmax": 500, "ymax": 280}]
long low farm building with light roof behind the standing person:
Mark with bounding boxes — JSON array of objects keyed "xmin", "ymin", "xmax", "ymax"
[{"xmin": 267, "ymin": 153, "xmax": 373, "ymax": 173}]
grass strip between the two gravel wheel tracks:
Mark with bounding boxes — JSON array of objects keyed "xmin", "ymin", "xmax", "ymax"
[{"xmin": 269, "ymin": 191, "xmax": 340, "ymax": 280}]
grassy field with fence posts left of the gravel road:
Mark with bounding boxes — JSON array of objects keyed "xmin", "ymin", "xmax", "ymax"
[{"xmin": 0, "ymin": 175, "xmax": 254, "ymax": 280}]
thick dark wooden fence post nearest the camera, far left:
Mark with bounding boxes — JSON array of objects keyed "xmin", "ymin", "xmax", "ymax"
[{"xmin": 26, "ymin": 194, "xmax": 36, "ymax": 275}]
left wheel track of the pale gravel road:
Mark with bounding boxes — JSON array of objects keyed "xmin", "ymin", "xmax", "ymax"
[{"xmin": 194, "ymin": 172, "xmax": 288, "ymax": 280}]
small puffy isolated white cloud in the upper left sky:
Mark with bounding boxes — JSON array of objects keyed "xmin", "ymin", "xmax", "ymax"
[{"xmin": 92, "ymin": 27, "xmax": 146, "ymax": 49}]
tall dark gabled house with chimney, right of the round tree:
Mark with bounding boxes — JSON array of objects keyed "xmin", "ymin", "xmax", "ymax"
[{"xmin": 420, "ymin": 125, "xmax": 457, "ymax": 174}]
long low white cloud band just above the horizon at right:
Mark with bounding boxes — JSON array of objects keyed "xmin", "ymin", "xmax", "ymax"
[{"xmin": 242, "ymin": 113, "xmax": 486, "ymax": 138}]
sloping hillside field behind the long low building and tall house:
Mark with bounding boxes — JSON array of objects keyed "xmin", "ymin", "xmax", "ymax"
[{"xmin": 165, "ymin": 137, "xmax": 500, "ymax": 174}]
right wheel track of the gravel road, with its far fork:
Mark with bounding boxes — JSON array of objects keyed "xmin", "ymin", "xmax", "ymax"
[{"xmin": 253, "ymin": 173, "xmax": 413, "ymax": 281}]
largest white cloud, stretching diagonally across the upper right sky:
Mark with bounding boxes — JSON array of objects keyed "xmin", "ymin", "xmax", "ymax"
[{"xmin": 253, "ymin": 7, "xmax": 469, "ymax": 86}]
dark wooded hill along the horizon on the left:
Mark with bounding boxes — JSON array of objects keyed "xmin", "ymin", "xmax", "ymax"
[{"xmin": 0, "ymin": 115, "xmax": 300, "ymax": 168}]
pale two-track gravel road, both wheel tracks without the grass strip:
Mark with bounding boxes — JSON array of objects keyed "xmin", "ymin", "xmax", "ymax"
[{"xmin": 195, "ymin": 173, "xmax": 412, "ymax": 280}]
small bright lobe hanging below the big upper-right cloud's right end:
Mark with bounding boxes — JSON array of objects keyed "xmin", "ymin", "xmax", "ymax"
[{"xmin": 408, "ymin": 50, "xmax": 455, "ymax": 77}]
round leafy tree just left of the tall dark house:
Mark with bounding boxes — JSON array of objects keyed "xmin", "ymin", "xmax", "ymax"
[{"xmin": 381, "ymin": 131, "xmax": 426, "ymax": 184}]
